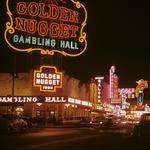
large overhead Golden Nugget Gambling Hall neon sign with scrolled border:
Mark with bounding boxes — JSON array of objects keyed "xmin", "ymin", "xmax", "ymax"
[{"xmin": 4, "ymin": 0, "xmax": 87, "ymax": 56}]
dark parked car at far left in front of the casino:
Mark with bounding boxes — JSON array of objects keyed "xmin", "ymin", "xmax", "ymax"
[{"xmin": 0, "ymin": 114, "xmax": 28, "ymax": 133}]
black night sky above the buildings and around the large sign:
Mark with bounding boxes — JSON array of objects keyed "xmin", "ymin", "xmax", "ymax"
[{"xmin": 0, "ymin": 0, "xmax": 150, "ymax": 99}]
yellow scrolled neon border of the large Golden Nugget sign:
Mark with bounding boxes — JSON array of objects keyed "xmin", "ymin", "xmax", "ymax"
[{"xmin": 4, "ymin": 0, "xmax": 87, "ymax": 57}]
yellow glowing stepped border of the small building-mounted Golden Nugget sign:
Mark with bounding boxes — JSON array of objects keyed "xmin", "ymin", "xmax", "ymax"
[{"xmin": 33, "ymin": 66, "xmax": 62, "ymax": 92}]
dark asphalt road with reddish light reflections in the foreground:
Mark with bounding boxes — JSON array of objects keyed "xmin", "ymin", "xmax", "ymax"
[{"xmin": 0, "ymin": 128, "xmax": 150, "ymax": 150}]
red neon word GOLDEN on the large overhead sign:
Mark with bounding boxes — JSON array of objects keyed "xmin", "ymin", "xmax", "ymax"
[{"xmin": 16, "ymin": 2, "xmax": 79, "ymax": 23}]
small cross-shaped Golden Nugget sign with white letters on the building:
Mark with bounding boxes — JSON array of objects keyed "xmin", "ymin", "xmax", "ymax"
[{"xmin": 34, "ymin": 66, "xmax": 62, "ymax": 92}]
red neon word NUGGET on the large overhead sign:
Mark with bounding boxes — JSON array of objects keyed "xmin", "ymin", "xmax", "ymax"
[{"xmin": 15, "ymin": 17, "xmax": 79, "ymax": 38}]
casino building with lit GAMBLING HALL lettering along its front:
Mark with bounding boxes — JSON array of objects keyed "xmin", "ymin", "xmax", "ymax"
[{"xmin": 0, "ymin": 71, "xmax": 93, "ymax": 120}]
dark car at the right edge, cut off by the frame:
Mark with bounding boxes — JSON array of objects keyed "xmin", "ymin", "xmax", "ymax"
[{"xmin": 131, "ymin": 113, "xmax": 150, "ymax": 140}]
